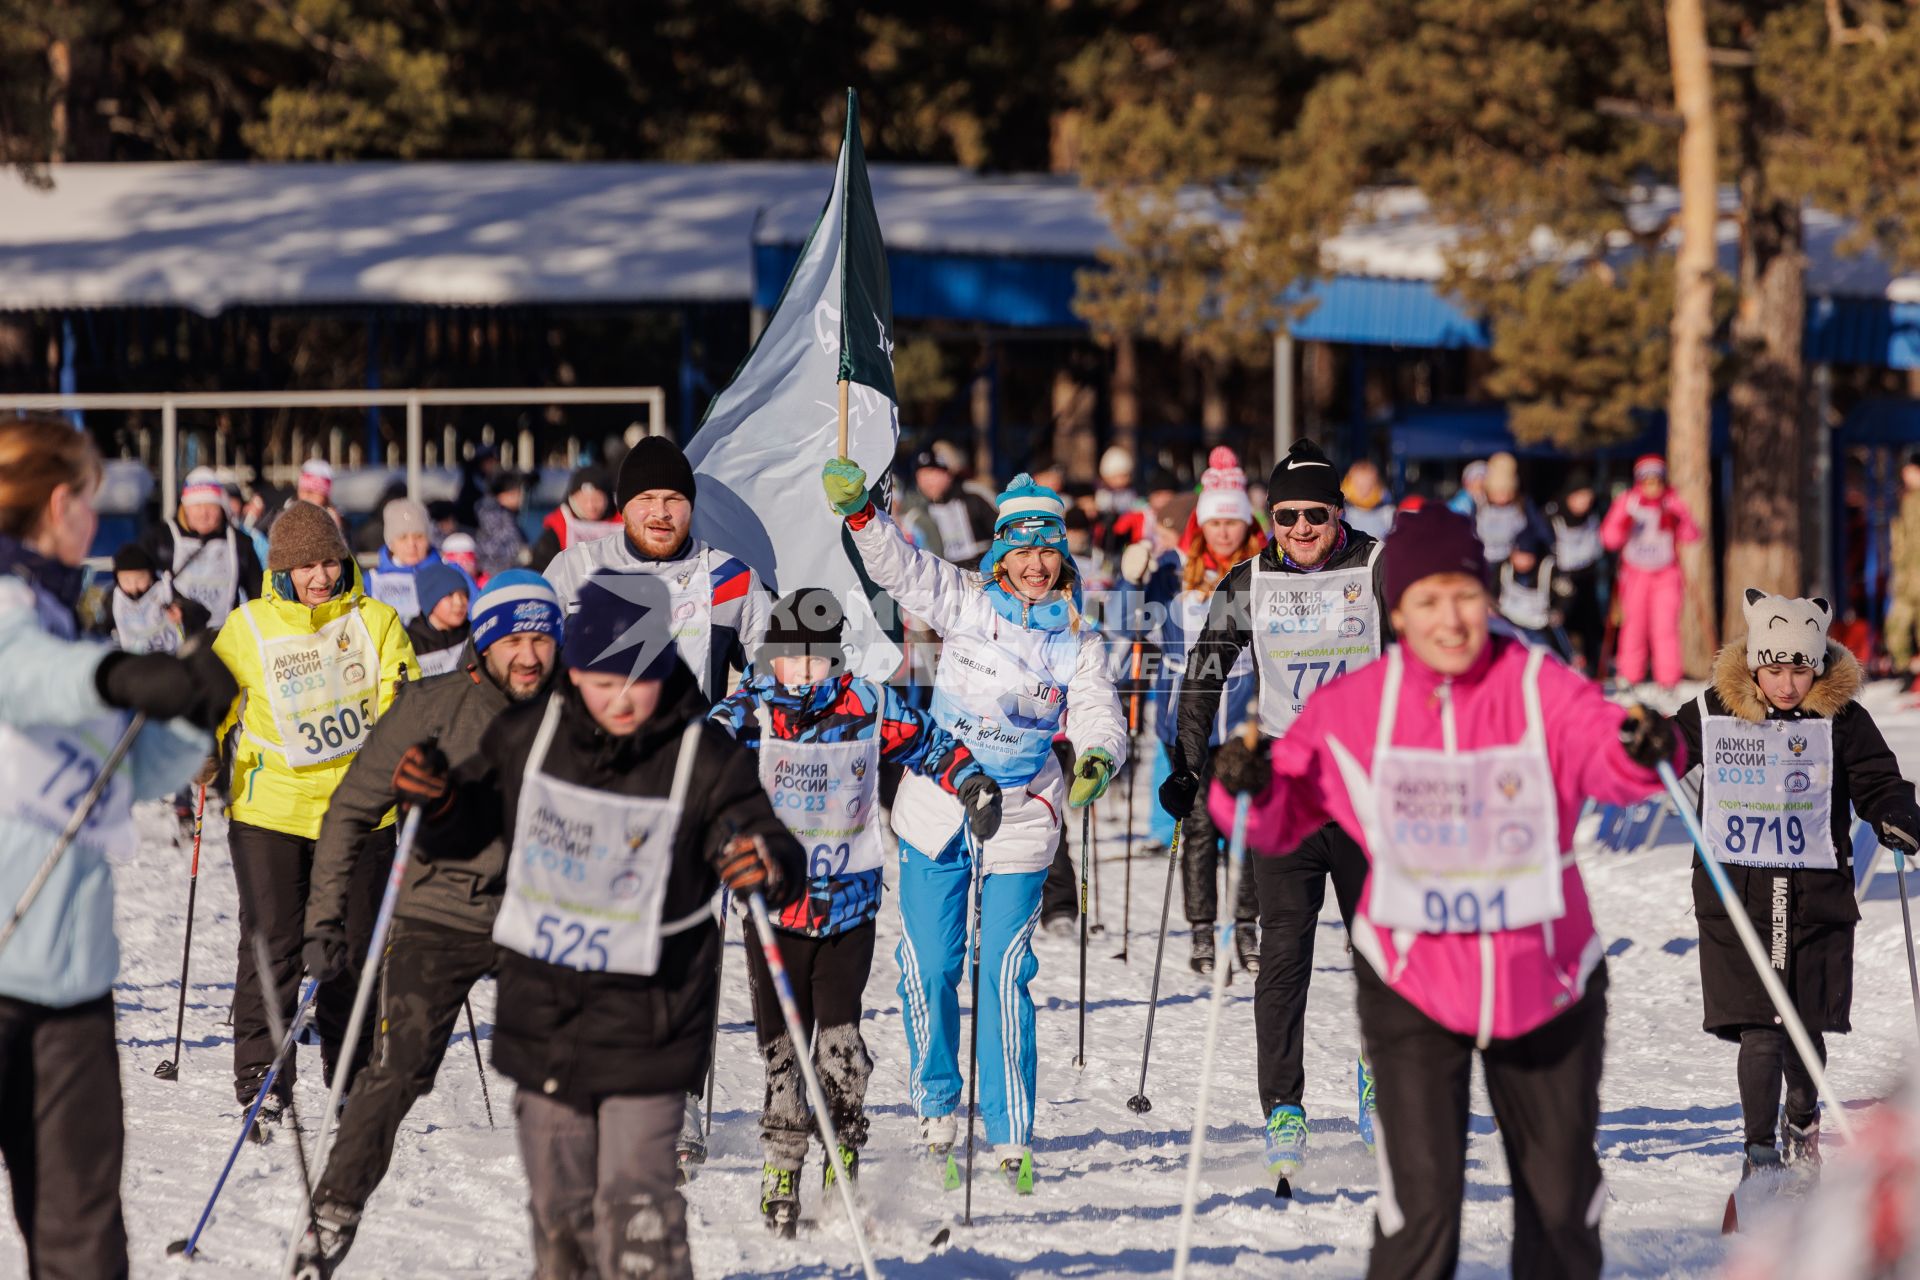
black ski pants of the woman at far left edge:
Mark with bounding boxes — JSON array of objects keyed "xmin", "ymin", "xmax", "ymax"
[{"xmin": 0, "ymin": 996, "xmax": 127, "ymax": 1280}]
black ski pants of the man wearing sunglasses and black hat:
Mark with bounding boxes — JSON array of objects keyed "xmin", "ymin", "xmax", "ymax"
[{"xmin": 1248, "ymin": 823, "xmax": 1379, "ymax": 1115}]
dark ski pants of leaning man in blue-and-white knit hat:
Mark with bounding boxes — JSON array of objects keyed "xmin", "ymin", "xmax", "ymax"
[{"xmin": 313, "ymin": 919, "xmax": 495, "ymax": 1209}]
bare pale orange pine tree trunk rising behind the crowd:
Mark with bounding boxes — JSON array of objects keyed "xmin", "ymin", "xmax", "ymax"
[{"xmin": 1667, "ymin": 0, "xmax": 1718, "ymax": 679}]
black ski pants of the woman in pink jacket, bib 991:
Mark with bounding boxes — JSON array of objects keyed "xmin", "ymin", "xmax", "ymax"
[{"xmin": 1354, "ymin": 954, "xmax": 1607, "ymax": 1280}]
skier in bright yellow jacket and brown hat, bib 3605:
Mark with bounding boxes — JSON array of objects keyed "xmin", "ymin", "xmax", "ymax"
[{"xmin": 213, "ymin": 503, "xmax": 419, "ymax": 1123}]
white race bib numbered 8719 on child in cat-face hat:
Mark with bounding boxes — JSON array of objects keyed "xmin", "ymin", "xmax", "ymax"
[{"xmin": 1699, "ymin": 716, "xmax": 1839, "ymax": 871}]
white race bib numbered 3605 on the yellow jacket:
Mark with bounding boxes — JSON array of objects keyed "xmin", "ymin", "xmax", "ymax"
[{"xmin": 248, "ymin": 610, "xmax": 380, "ymax": 768}]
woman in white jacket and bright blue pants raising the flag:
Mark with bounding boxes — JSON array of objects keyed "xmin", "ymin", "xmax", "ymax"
[{"xmin": 824, "ymin": 459, "xmax": 1127, "ymax": 1192}]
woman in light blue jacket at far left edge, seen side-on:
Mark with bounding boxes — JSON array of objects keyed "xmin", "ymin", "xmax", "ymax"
[{"xmin": 0, "ymin": 418, "xmax": 234, "ymax": 1278}]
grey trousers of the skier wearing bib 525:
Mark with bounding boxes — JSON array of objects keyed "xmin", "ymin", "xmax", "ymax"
[{"xmin": 513, "ymin": 1088, "xmax": 693, "ymax": 1280}]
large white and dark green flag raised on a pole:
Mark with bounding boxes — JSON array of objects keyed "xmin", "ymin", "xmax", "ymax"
[{"xmin": 687, "ymin": 90, "xmax": 900, "ymax": 679}]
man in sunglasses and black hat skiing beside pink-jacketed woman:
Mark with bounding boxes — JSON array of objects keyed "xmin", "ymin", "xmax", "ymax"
[{"xmin": 1160, "ymin": 439, "xmax": 1405, "ymax": 1178}]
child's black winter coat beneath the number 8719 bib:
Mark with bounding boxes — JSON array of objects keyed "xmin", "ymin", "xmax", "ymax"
[{"xmin": 1674, "ymin": 639, "xmax": 1920, "ymax": 1040}]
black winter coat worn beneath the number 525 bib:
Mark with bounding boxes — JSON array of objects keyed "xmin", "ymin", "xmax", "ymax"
[{"xmin": 444, "ymin": 662, "xmax": 806, "ymax": 1107}]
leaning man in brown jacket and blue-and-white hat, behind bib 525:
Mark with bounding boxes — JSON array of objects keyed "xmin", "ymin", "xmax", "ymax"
[{"xmin": 296, "ymin": 570, "xmax": 561, "ymax": 1278}]
